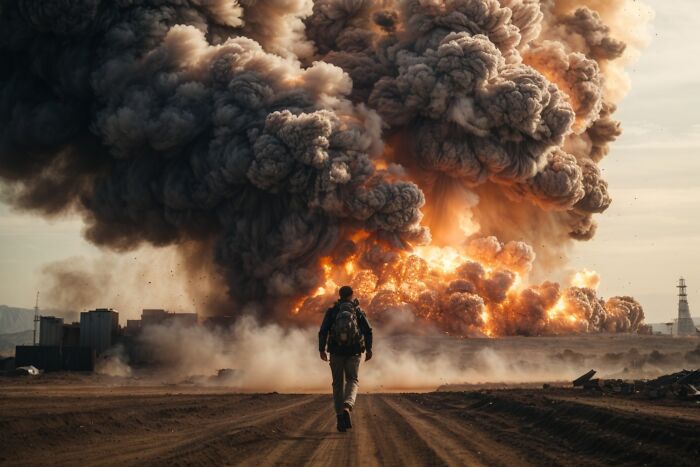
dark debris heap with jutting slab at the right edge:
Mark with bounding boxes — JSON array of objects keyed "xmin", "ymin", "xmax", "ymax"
[{"xmin": 572, "ymin": 370, "xmax": 700, "ymax": 401}]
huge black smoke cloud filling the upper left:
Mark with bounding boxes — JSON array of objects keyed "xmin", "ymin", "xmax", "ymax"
[{"xmin": 0, "ymin": 0, "xmax": 424, "ymax": 314}]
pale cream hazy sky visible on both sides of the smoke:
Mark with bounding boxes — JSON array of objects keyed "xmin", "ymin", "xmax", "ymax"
[{"xmin": 0, "ymin": 0, "xmax": 700, "ymax": 322}]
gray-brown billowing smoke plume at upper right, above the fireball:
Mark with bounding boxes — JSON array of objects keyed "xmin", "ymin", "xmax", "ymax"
[{"xmin": 307, "ymin": 0, "xmax": 624, "ymax": 238}]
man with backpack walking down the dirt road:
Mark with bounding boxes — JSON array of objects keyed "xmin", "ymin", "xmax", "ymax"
[{"xmin": 318, "ymin": 285, "xmax": 372, "ymax": 432}]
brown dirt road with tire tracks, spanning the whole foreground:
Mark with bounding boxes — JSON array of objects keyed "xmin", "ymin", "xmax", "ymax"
[{"xmin": 0, "ymin": 383, "xmax": 700, "ymax": 466}]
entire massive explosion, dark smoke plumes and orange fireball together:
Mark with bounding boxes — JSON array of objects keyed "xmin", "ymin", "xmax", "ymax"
[{"xmin": 0, "ymin": 0, "xmax": 649, "ymax": 336}]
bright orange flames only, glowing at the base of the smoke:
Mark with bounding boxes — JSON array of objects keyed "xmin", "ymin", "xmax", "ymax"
[{"xmin": 292, "ymin": 231, "xmax": 598, "ymax": 337}]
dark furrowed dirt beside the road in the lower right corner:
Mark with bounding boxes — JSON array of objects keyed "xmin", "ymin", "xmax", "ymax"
[{"xmin": 410, "ymin": 391, "xmax": 700, "ymax": 465}]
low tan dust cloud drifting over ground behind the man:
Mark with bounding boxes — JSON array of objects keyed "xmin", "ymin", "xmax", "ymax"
[{"xmin": 103, "ymin": 317, "xmax": 698, "ymax": 392}]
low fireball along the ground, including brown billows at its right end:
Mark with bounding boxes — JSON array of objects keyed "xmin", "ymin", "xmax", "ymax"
[{"xmin": 294, "ymin": 237, "xmax": 644, "ymax": 336}]
